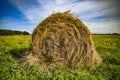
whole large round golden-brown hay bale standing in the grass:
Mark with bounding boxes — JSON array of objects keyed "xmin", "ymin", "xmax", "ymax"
[{"xmin": 26, "ymin": 12, "xmax": 100, "ymax": 67}]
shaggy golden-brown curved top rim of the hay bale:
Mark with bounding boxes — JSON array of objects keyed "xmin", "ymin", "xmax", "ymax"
[{"xmin": 33, "ymin": 11, "xmax": 90, "ymax": 34}]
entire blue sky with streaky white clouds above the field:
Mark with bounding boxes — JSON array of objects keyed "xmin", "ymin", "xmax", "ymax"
[{"xmin": 0, "ymin": 0, "xmax": 120, "ymax": 34}]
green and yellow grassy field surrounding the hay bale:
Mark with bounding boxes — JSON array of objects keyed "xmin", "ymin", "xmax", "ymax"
[{"xmin": 0, "ymin": 35, "xmax": 120, "ymax": 80}]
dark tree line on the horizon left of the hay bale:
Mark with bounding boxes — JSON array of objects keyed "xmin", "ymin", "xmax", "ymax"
[{"xmin": 0, "ymin": 29, "xmax": 30, "ymax": 35}]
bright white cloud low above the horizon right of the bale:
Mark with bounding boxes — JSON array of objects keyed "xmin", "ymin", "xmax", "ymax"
[{"xmin": 84, "ymin": 19, "xmax": 120, "ymax": 33}]
